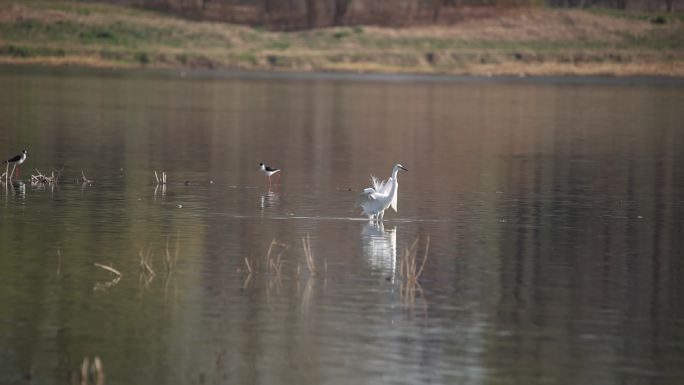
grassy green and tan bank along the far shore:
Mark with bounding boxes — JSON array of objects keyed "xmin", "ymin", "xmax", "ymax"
[{"xmin": 0, "ymin": 1, "xmax": 684, "ymax": 77}]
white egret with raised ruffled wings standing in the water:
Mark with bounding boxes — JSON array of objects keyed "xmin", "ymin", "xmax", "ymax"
[{"xmin": 361, "ymin": 163, "xmax": 408, "ymax": 221}]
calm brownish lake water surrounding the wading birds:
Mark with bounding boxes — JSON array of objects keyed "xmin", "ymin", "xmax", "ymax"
[{"xmin": 0, "ymin": 67, "xmax": 684, "ymax": 385}]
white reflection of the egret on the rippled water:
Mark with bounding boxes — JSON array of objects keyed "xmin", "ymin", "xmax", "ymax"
[{"xmin": 361, "ymin": 222, "xmax": 397, "ymax": 281}]
